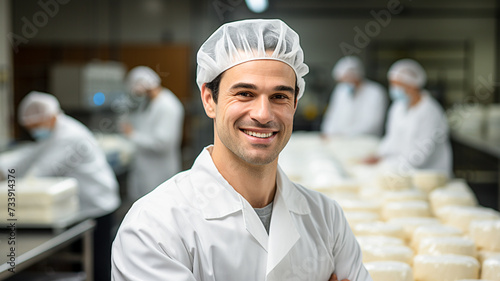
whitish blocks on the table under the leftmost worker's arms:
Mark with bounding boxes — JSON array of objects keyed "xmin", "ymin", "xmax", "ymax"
[{"xmin": 0, "ymin": 177, "xmax": 79, "ymax": 225}]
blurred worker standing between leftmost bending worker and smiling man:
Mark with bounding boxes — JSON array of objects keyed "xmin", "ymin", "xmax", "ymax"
[{"xmin": 122, "ymin": 66, "xmax": 184, "ymax": 201}]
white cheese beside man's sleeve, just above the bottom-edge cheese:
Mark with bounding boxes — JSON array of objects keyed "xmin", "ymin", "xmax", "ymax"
[{"xmin": 361, "ymin": 245, "xmax": 414, "ymax": 265}]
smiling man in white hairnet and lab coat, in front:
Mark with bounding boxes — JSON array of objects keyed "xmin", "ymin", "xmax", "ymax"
[{"xmin": 112, "ymin": 20, "xmax": 372, "ymax": 281}]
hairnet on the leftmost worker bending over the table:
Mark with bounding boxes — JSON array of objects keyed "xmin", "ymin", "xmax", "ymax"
[{"xmin": 18, "ymin": 91, "xmax": 61, "ymax": 126}]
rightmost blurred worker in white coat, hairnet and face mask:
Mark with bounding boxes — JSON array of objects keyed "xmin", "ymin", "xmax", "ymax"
[{"xmin": 366, "ymin": 59, "xmax": 452, "ymax": 176}]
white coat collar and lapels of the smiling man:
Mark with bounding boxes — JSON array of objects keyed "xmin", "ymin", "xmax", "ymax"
[{"xmin": 191, "ymin": 147, "xmax": 310, "ymax": 266}]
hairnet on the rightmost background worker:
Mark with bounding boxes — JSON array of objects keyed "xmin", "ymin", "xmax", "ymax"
[{"xmin": 387, "ymin": 59, "xmax": 427, "ymax": 88}]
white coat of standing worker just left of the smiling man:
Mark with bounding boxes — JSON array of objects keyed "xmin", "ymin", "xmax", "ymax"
[{"xmin": 128, "ymin": 89, "xmax": 184, "ymax": 200}]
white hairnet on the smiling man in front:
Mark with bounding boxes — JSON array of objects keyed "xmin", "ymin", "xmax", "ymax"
[{"xmin": 196, "ymin": 19, "xmax": 309, "ymax": 98}]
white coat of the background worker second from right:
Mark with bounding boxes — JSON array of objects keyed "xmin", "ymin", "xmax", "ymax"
[{"xmin": 321, "ymin": 80, "xmax": 387, "ymax": 136}]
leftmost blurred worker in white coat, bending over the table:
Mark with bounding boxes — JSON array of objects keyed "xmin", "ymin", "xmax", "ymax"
[{"xmin": 0, "ymin": 92, "xmax": 120, "ymax": 280}]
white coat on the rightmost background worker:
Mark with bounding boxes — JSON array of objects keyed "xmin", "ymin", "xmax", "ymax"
[{"xmin": 378, "ymin": 91, "xmax": 452, "ymax": 176}]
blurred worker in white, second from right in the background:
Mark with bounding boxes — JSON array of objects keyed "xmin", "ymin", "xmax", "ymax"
[{"xmin": 321, "ymin": 56, "xmax": 387, "ymax": 136}]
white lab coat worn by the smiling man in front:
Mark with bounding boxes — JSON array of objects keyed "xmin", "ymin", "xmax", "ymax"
[{"xmin": 112, "ymin": 149, "xmax": 372, "ymax": 281}]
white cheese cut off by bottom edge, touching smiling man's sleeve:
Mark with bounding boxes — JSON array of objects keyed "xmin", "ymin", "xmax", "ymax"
[{"xmin": 364, "ymin": 261, "xmax": 413, "ymax": 281}]
